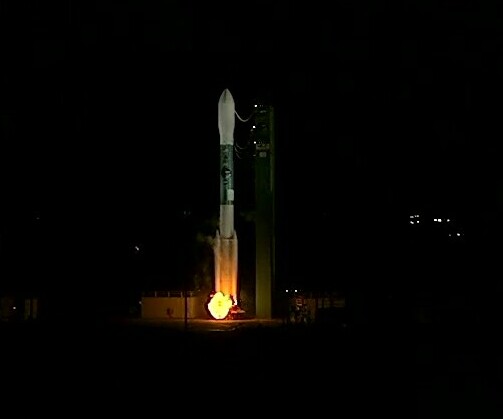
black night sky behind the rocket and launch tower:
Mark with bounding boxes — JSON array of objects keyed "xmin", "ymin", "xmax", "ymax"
[{"xmin": 0, "ymin": 0, "xmax": 503, "ymax": 310}]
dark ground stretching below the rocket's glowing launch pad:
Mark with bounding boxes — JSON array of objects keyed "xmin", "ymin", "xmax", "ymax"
[{"xmin": 0, "ymin": 319, "xmax": 502, "ymax": 418}]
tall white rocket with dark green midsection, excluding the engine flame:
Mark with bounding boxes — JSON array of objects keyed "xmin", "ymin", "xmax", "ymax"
[{"xmin": 214, "ymin": 89, "xmax": 238, "ymax": 303}]
